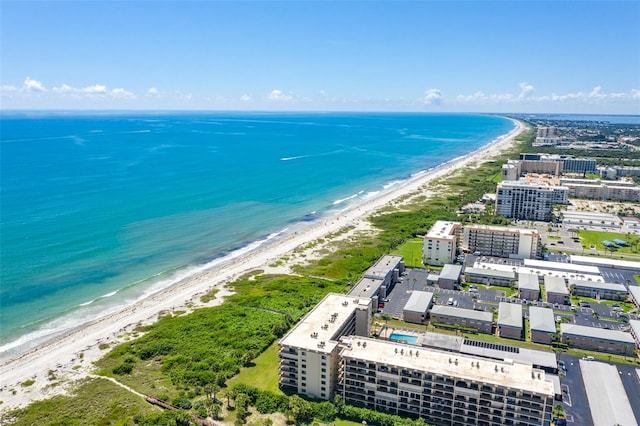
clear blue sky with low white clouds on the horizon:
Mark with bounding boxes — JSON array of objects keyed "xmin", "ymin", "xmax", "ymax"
[{"xmin": 0, "ymin": 0, "xmax": 640, "ymax": 114}]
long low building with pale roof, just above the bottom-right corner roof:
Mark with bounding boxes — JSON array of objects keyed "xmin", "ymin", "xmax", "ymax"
[{"xmin": 560, "ymin": 323, "xmax": 636, "ymax": 355}]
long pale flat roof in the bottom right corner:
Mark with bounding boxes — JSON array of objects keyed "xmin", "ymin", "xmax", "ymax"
[{"xmin": 580, "ymin": 360, "xmax": 638, "ymax": 426}]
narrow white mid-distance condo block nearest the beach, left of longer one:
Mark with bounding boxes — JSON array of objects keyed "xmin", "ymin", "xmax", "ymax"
[{"xmin": 422, "ymin": 220, "xmax": 462, "ymax": 265}]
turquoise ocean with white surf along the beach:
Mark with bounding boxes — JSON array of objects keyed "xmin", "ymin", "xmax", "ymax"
[{"xmin": 0, "ymin": 112, "xmax": 514, "ymax": 357}]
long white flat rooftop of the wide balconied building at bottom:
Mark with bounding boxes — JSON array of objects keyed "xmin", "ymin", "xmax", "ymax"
[{"xmin": 340, "ymin": 336, "xmax": 554, "ymax": 397}]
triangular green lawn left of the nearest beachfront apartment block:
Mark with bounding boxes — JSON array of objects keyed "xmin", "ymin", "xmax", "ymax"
[{"xmin": 227, "ymin": 341, "xmax": 282, "ymax": 394}]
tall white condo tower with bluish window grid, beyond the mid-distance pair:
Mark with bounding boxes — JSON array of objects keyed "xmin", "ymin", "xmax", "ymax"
[{"xmin": 496, "ymin": 180, "xmax": 567, "ymax": 221}]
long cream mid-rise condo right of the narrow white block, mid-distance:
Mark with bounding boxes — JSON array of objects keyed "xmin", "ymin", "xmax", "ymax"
[{"xmin": 461, "ymin": 225, "xmax": 542, "ymax": 259}]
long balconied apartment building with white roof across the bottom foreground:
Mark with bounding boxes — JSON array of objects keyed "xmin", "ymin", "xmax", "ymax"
[{"xmin": 338, "ymin": 337, "xmax": 555, "ymax": 426}]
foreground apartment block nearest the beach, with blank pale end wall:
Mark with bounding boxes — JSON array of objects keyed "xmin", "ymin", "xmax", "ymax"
[{"xmin": 279, "ymin": 294, "xmax": 372, "ymax": 400}]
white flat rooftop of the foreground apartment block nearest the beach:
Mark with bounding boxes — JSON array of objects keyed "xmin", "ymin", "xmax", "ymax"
[{"xmin": 280, "ymin": 293, "xmax": 371, "ymax": 353}]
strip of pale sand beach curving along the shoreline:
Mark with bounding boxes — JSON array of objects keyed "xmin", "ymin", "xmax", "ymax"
[{"xmin": 0, "ymin": 122, "xmax": 526, "ymax": 411}]
